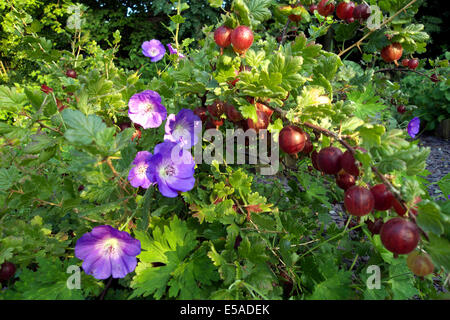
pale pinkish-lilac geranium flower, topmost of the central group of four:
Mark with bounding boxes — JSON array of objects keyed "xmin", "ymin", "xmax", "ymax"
[{"xmin": 128, "ymin": 90, "xmax": 167, "ymax": 129}]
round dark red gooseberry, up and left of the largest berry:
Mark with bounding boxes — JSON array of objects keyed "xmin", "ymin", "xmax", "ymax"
[{"xmin": 344, "ymin": 186, "xmax": 375, "ymax": 217}]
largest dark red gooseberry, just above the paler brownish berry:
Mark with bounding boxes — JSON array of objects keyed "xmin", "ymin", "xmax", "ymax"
[{"xmin": 380, "ymin": 217, "xmax": 420, "ymax": 254}]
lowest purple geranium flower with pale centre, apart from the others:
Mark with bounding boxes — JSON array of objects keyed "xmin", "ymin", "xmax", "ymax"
[{"xmin": 75, "ymin": 225, "xmax": 141, "ymax": 279}]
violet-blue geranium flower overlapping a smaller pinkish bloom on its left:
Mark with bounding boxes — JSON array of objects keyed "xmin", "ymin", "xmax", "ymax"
[{"xmin": 147, "ymin": 141, "xmax": 195, "ymax": 198}]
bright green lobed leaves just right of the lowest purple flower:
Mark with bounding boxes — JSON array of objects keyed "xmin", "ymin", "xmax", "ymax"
[{"xmin": 131, "ymin": 216, "xmax": 217, "ymax": 299}]
